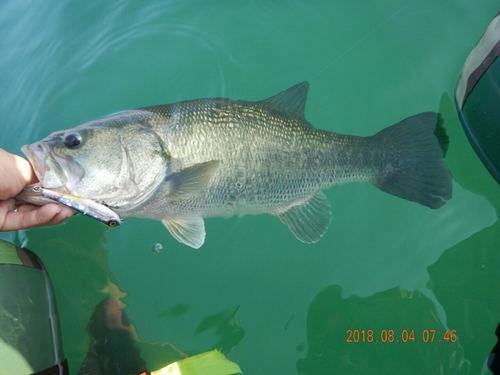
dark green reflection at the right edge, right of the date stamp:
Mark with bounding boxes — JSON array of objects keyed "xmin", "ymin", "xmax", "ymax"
[{"xmin": 428, "ymin": 221, "xmax": 500, "ymax": 373}]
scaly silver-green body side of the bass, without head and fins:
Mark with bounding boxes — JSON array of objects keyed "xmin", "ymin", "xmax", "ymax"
[{"xmin": 139, "ymin": 99, "xmax": 380, "ymax": 217}]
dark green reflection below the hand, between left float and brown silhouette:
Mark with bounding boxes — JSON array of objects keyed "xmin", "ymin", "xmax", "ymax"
[{"xmin": 26, "ymin": 215, "xmax": 119, "ymax": 374}]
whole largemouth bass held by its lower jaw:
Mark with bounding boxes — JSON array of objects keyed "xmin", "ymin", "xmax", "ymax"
[{"xmin": 22, "ymin": 82, "xmax": 452, "ymax": 248}]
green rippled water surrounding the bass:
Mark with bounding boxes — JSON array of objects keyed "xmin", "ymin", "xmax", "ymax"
[{"xmin": 0, "ymin": 0, "xmax": 500, "ymax": 375}]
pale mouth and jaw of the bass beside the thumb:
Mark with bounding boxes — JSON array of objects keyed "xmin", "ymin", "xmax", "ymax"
[{"xmin": 21, "ymin": 142, "xmax": 67, "ymax": 191}]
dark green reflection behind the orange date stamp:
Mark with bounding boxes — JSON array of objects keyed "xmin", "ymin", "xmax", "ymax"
[{"xmin": 297, "ymin": 285, "xmax": 469, "ymax": 375}]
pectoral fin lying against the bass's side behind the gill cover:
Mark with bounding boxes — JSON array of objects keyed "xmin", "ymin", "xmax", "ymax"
[{"xmin": 165, "ymin": 160, "xmax": 220, "ymax": 199}]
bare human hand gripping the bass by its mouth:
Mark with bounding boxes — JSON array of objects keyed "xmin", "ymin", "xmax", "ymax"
[{"xmin": 0, "ymin": 148, "xmax": 74, "ymax": 232}]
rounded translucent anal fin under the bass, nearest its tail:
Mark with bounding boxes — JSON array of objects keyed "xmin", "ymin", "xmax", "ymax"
[{"xmin": 277, "ymin": 191, "xmax": 332, "ymax": 243}]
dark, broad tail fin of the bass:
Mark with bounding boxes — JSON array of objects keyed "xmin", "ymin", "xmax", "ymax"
[{"xmin": 372, "ymin": 112, "xmax": 452, "ymax": 209}]
